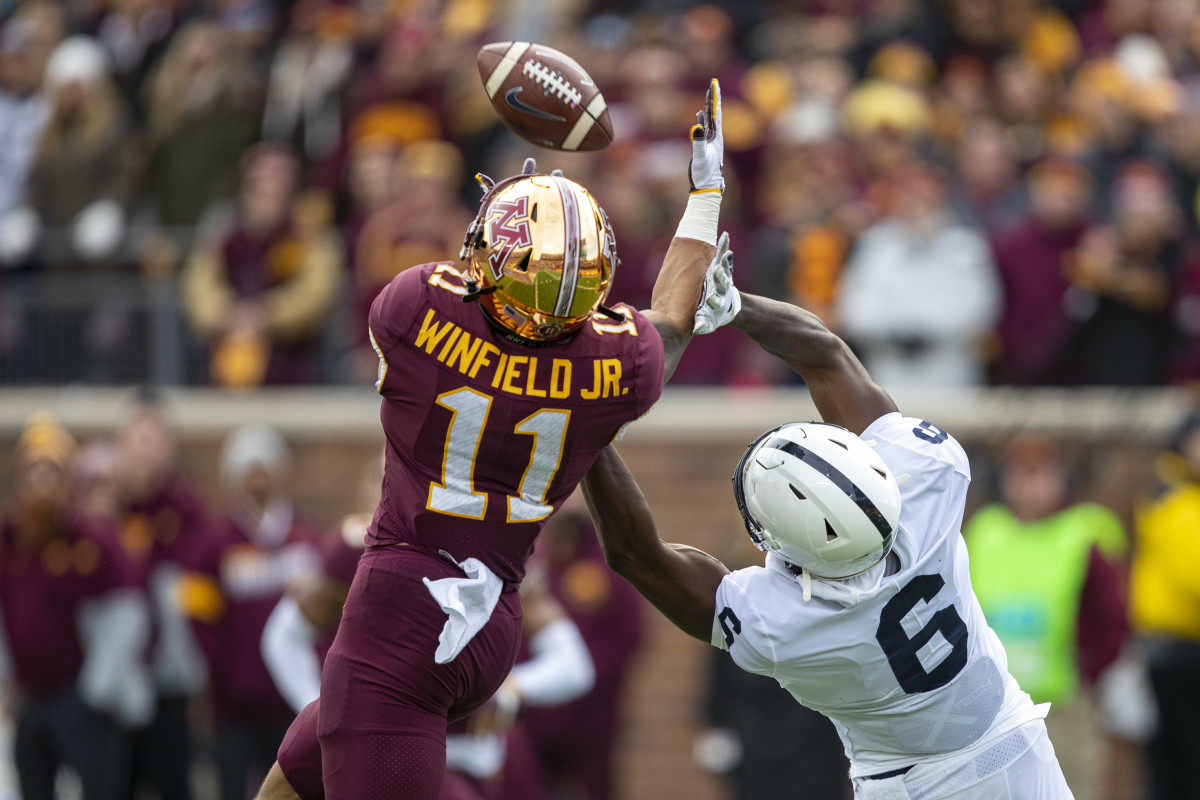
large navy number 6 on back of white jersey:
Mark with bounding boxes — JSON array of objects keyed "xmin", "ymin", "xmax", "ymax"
[{"xmin": 875, "ymin": 575, "xmax": 967, "ymax": 694}]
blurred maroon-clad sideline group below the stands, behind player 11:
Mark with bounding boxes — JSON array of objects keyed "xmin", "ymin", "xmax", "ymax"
[{"xmin": 0, "ymin": 395, "xmax": 642, "ymax": 800}]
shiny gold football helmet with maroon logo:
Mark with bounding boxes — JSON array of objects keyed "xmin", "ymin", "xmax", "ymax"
[{"xmin": 461, "ymin": 158, "xmax": 618, "ymax": 342}]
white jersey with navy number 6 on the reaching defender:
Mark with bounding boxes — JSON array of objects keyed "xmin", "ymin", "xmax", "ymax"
[{"xmin": 713, "ymin": 413, "xmax": 1045, "ymax": 777}]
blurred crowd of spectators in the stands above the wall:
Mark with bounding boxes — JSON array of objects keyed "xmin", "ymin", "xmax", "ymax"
[{"xmin": 7, "ymin": 0, "xmax": 1200, "ymax": 389}]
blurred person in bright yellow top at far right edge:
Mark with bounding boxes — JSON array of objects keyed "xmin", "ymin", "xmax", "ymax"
[{"xmin": 1129, "ymin": 414, "xmax": 1200, "ymax": 800}]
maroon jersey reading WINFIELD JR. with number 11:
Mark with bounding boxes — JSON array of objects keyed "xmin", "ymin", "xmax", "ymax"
[{"xmin": 367, "ymin": 263, "xmax": 664, "ymax": 583}]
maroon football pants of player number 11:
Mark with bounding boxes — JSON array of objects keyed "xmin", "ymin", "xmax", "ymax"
[{"xmin": 280, "ymin": 546, "xmax": 522, "ymax": 800}]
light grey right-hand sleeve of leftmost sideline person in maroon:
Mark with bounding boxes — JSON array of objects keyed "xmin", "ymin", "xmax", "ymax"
[{"xmin": 77, "ymin": 587, "xmax": 154, "ymax": 727}]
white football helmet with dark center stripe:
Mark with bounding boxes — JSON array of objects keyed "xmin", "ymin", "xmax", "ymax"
[{"xmin": 733, "ymin": 422, "xmax": 900, "ymax": 579}]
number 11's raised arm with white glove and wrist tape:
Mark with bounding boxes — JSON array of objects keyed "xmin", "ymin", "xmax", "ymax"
[{"xmin": 646, "ymin": 78, "xmax": 725, "ymax": 381}]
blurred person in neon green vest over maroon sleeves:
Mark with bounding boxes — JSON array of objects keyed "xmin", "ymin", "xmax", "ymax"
[{"xmin": 964, "ymin": 435, "xmax": 1130, "ymax": 800}]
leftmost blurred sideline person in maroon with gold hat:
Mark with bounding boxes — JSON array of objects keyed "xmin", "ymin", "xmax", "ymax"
[{"xmin": 0, "ymin": 416, "xmax": 152, "ymax": 800}]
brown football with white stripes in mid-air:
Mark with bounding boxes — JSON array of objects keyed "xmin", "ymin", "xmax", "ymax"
[{"xmin": 476, "ymin": 42, "xmax": 612, "ymax": 150}]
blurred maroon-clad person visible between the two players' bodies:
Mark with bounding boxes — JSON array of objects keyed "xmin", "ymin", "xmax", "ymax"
[{"xmin": 524, "ymin": 507, "xmax": 642, "ymax": 800}]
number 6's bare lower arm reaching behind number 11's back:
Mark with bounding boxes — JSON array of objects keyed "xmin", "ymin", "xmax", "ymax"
[{"xmin": 583, "ymin": 445, "xmax": 728, "ymax": 642}]
